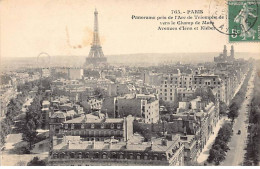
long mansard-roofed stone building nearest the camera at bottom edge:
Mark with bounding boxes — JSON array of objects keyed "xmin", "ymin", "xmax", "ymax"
[{"xmin": 48, "ymin": 136, "xmax": 184, "ymax": 166}]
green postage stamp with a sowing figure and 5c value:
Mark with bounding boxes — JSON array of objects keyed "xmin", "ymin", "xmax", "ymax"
[{"xmin": 228, "ymin": 0, "xmax": 260, "ymax": 42}]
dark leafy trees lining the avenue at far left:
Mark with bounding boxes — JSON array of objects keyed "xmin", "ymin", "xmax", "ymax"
[{"xmin": 0, "ymin": 78, "xmax": 50, "ymax": 149}]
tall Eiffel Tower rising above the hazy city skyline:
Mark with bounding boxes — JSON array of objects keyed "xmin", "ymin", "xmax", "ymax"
[{"xmin": 85, "ymin": 9, "xmax": 107, "ymax": 66}]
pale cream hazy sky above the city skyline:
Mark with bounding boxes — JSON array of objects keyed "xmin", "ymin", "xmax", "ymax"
[{"xmin": 0, "ymin": 0, "xmax": 260, "ymax": 57}]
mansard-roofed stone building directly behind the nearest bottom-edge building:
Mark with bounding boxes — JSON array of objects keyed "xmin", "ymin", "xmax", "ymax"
[{"xmin": 49, "ymin": 112, "xmax": 133, "ymax": 141}]
